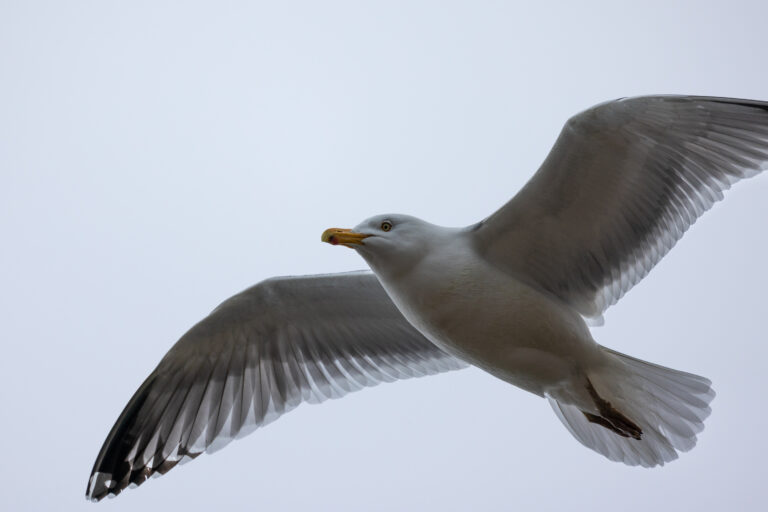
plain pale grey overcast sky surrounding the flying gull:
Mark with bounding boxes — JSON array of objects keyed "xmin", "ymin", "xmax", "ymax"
[{"xmin": 0, "ymin": 0, "xmax": 768, "ymax": 511}]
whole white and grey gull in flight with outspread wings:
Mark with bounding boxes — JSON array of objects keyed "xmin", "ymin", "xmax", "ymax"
[{"xmin": 86, "ymin": 96, "xmax": 768, "ymax": 501}]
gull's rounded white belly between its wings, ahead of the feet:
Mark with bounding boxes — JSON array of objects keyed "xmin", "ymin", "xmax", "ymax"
[{"xmin": 382, "ymin": 261, "xmax": 597, "ymax": 395}]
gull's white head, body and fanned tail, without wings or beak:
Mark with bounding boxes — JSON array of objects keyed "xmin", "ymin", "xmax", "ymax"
[{"xmin": 344, "ymin": 214, "xmax": 714, "ymax": 467}]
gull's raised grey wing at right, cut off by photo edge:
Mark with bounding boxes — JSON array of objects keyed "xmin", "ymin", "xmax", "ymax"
[{"xmin": 473, "ymin": 96, "xmax": 768, "ymax": 321}]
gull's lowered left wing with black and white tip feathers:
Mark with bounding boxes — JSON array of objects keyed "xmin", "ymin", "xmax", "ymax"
[{"xmin": 86, "ymin": 272, "xmax": 466, "ymax": 500}]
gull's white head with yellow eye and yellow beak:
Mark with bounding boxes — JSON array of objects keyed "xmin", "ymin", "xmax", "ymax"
[{"xmin": 321, "ymin": 214, "xmax": 440, "ymax": 272}]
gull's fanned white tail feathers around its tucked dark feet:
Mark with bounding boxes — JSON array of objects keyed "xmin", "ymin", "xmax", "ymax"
[{"xmin": 549, "ymin": 347, "xmax": 715, "ymax": 467}]
